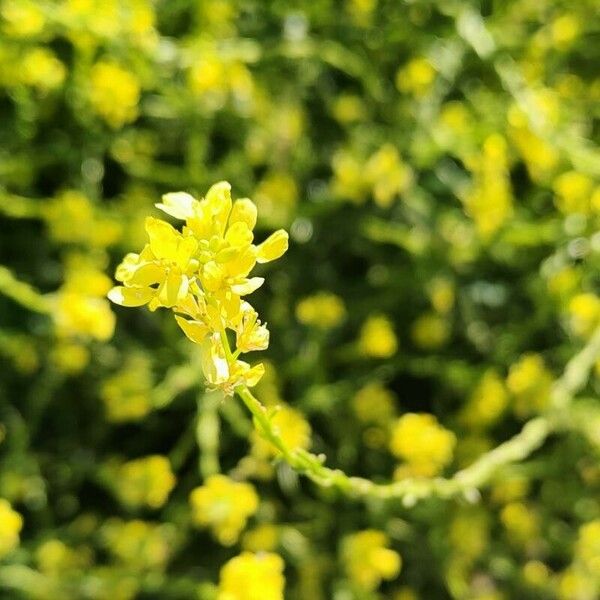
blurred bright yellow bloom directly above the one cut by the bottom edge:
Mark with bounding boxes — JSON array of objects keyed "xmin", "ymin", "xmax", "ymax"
[{"xmin": 190, "ymin": 475, "xmax": 258, "ymax": 546}]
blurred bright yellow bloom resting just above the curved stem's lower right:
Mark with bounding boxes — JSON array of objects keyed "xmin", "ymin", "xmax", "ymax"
[{"xmin": 390, "ymin": 413, "xmax": 456, "ymax": 475}]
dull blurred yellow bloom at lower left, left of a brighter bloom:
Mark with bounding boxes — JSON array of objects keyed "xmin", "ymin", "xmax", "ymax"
[{"xmin": 114, "ymin": 455, "xmax": 176, "ymax": 509}]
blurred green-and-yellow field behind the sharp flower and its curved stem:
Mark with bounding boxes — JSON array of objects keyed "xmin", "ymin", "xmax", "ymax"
[{"xmin": 0, "ymin": 0, "xmax": 600, "ymax": 600}]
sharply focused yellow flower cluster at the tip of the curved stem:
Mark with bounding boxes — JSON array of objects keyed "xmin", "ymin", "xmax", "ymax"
[{"xmin": 108, "ymin": 181, "xmax": 288, "ymax": 395}]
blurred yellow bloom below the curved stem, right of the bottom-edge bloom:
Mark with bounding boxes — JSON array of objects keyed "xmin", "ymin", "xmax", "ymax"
[{"xmin": 341, "ymin": 529, "xmax": 402, "ymax": 591}]
